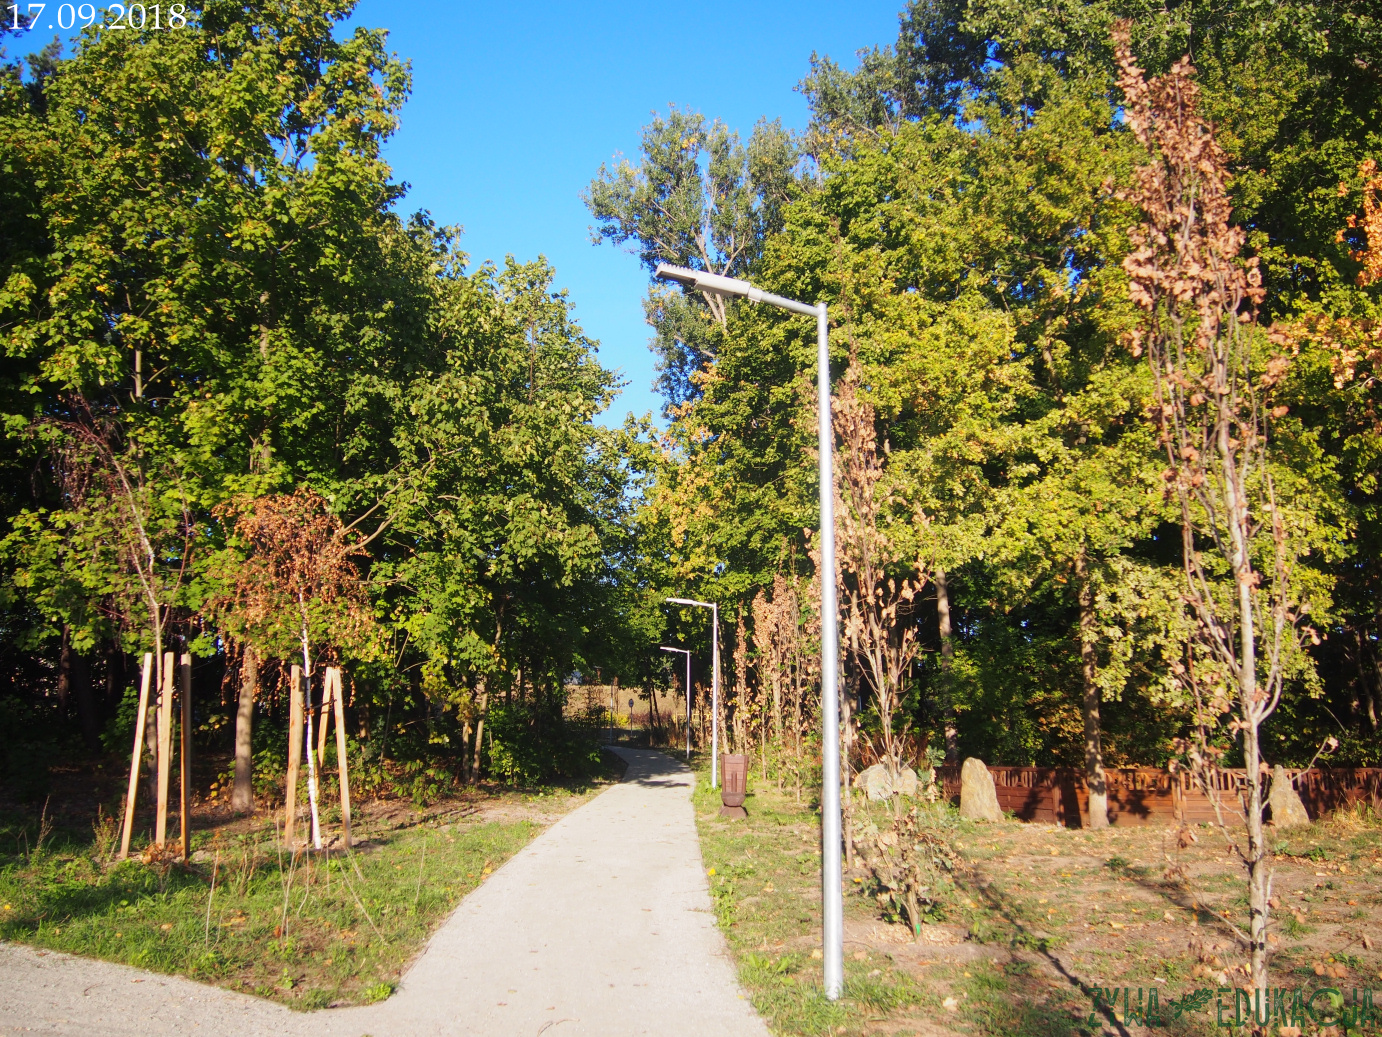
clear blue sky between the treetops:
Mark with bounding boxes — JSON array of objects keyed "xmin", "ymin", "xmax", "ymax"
[{"xmin": 344, "ymin": 0, "xmax": 905, "ymax": 424}]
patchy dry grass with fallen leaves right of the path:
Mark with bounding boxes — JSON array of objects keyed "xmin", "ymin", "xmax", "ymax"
[{"xmin": 695, "ymin": 772, "xmax": 1382, "ymax": 1037}]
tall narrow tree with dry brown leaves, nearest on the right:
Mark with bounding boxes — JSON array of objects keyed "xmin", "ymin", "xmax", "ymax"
[{"xmin": 1114, "ymin": 24, "xmax": 1309, "ymax": 996}]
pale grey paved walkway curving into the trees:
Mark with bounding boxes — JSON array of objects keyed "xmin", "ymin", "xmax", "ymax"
[{"xmin": 0, "ymin": 749, "xmax": 767, "ymax": 1037}]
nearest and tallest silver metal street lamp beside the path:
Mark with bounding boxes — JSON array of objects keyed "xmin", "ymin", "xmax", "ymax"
[{"xmin": 656, "ymin": 263, "xmax": 844, "ymax": 1001}]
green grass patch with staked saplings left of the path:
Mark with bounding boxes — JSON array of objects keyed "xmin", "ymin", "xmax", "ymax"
[{"xmin": 0, "ymin": 821, "xmax": 539, "ymax": 1009}]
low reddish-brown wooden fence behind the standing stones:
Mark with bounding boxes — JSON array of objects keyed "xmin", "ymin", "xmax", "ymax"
[{"xmin": 940, "ymin": 766, "xmax": 1382, "ymax": 828}]
